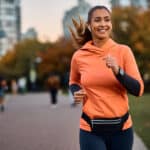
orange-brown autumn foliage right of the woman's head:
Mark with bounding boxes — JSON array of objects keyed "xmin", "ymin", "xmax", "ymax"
[{"xmin": 112, "ymin": 7, "xmax": 150, "ymax": 54}]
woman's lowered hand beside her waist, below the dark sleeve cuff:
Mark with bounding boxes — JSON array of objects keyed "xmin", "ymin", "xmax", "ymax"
[{"xmin": 73, "ymin": 89, "xmax": 86, "ymax": 104}]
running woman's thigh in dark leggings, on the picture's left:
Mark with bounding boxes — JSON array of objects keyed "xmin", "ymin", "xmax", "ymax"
[{"xmin": 80, "ymin": 130, "xmax": 106, "ymax": 150}]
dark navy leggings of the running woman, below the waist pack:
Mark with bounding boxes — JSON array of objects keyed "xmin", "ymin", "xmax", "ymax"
[{"xmin": 80, "ymin": 128, "xmax": 133, "ymax": 150}]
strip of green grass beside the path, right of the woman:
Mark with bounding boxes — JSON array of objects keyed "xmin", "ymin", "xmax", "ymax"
[{"xmin": 129, "ymin": 94, "xmax": 150, "ymax": 149}]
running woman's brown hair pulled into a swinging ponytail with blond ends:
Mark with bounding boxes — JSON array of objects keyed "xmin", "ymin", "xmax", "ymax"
[{"xmin": 69, "ymin": 6, "xmax": 111, "ymax": 49}]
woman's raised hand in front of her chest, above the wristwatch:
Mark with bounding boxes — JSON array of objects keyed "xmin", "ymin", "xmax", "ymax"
[{"xmin": 103, "ymin": 55, "xmax": 119, "ymax": 75}]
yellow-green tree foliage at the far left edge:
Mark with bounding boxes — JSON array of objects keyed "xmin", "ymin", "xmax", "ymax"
[{"xmin": 0, "ymin": 40, "xmax": 45, "ymax": 79}]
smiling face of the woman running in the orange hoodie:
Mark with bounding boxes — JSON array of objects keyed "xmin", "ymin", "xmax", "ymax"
[{"xmin": 89, "ymin": 9, "xmax": 112, "ymax": 40}]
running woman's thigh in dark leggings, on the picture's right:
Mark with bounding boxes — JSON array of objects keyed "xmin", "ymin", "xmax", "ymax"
[{"xmin": 111, "ymin": 128, "xmax": 133, "ymax": 150}]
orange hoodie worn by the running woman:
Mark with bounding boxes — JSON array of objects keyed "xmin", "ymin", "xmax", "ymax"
[{"xmin": 69, "ymin": 39, "xmax": 144, "ymax": 131}]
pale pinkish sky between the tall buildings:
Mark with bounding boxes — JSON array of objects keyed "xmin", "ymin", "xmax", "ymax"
[{"xmin": 21, "ymin": 0, "xmax": 110, "ymax": 42}]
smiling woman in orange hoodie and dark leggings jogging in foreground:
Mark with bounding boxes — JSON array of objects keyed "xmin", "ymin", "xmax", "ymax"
[{"xmin": 69, "ymin": 6, "xmax": 144, "ymax": 150}]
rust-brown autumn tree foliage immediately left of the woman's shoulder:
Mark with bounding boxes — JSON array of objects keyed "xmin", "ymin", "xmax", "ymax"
[{"xmin": 38, "ymin": 38, "xmax": 74, "ymax": 78}]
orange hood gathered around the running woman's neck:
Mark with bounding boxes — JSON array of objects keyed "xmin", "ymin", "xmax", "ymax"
[{"xmin": 80, "ymin": 38, "xmax": 117, "ymax": 56}]
